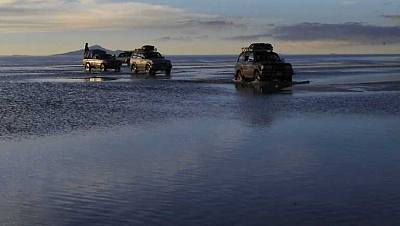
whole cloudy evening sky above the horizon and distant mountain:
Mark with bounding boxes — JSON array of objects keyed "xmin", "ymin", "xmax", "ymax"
[{"xmin": 0, "ymin": 0, "xmax": 400, "ymax": 55}]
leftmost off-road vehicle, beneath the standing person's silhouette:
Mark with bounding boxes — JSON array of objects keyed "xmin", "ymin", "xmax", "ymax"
[{"xmin": 82, "ymin": 49, "xmax": 121, "ymax": 72}]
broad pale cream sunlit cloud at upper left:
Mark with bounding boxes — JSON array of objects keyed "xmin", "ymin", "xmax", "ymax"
[{"xmin": 0, "ymin": 0, "xmax": 235, "ymax": 33}]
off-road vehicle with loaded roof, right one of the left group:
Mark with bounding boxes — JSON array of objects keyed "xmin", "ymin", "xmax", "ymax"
[{"xmin": 130, "ymin": 46, "xmax": 172, "ymax": 76}]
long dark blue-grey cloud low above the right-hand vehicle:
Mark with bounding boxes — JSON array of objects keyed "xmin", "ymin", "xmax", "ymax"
[{"xmin": 228, "ymin": 23, "xmax": 400, "ymax": 44}]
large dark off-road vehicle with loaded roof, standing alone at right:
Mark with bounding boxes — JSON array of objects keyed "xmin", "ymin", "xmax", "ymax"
[{"xmin": 235, "ymin": 43, "xmax": 293, "ymax": 89}]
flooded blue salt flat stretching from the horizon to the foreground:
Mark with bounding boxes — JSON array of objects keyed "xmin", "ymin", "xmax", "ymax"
[{"xmin": 0, "ymin": 55, "xmax": 400, "ymax": 225}]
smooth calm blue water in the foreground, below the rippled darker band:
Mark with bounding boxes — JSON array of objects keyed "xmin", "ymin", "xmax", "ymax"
[{"xmin": 0, "ymin": 115, "xmax": 400, "ymax": 225}]
